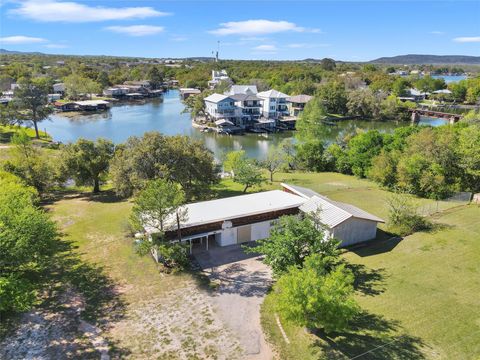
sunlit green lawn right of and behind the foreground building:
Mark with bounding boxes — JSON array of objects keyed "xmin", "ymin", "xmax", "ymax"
[{"xmin": 255, "ymin": 173, "xmax": 480, "ymax": 359}]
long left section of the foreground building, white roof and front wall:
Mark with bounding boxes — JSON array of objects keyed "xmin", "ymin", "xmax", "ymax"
[{"xmin": 144, "ymin": 190, "xmax": 305, "ymax": 256}]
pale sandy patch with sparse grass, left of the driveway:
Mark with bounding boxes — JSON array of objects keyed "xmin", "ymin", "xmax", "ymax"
[{"xmin": 110, "ymin": 282, "xmax": 242, "ymax": 359}]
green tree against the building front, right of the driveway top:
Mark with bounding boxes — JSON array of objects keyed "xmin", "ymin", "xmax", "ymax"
[{"xmin": 249, "ymin": 215, "xmax": 339, "ymax": 276}]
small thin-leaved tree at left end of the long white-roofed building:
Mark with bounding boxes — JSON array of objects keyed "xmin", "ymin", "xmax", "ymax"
[{"xmin": 131, "ymin": 179, "xmax": 188, "ymax": 268}]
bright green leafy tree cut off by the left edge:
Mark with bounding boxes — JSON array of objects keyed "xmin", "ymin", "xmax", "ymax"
[{"xmin": 0, "ymin": 172, "xmax": 60, "ymax": 313}]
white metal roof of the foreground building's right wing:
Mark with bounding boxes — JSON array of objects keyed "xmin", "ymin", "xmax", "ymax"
[{"xmin": 300, "ymin": 195, "xmax": 384, "ymax": 228}]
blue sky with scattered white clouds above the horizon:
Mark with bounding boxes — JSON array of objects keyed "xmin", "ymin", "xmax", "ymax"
[{"xmin": 0, "ymin": 0, "xmax": 480, "ymax": 61}]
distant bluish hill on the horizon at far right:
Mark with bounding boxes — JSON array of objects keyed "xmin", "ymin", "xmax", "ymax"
[{"xmin": 369, "ymin": 54, "xmax": 480, "ymax": 65}]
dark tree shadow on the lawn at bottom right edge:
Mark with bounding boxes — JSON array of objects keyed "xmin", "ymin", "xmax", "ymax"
[{"xmin": 312, "ymin": 311, "xmax": 426, "ymax": 360}]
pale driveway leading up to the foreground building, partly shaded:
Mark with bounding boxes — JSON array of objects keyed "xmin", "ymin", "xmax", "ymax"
[{"xmin": 195, "ymin": 245, "xmax": 273, "ymax": 360}]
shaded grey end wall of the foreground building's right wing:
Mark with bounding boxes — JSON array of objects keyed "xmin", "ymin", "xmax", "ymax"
[{"xmin": 331, "ymin": 218, "xmax": 377, "ymax": 246}]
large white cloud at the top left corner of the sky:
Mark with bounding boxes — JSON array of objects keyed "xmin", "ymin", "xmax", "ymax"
[{"xmin": 10, "ymin": 0, "xmax": 170, "ymax": 23}]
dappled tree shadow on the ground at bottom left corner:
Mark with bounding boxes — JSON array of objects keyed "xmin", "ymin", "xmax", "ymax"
[{"xmin": 0, "ymin": 240, "xmax": 129, "ymax": 359}]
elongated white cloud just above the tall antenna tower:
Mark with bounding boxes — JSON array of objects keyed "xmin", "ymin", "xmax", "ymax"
[{"xmin": 209, "ymin": 19, "xmax": 320, "ymax": 35}]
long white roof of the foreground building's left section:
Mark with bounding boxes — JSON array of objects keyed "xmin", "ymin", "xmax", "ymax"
[{"xmin": 145, "ymin": 190, "xmax": 306, "ymax": 233}]
